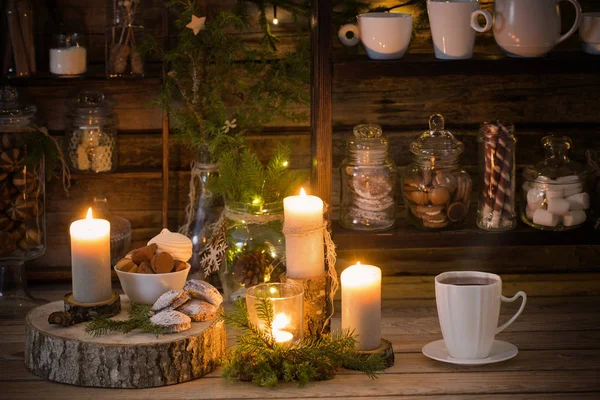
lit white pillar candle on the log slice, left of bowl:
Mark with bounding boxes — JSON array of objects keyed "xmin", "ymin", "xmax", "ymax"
[{"xmin": 70, "ymin": 208, "xmax": 112, "ymax": 303}]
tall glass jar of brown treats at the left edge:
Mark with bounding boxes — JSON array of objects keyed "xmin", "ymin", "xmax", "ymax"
[{"xmin": 0, "ymin": 86, "xmax": 46, "ymax": 318}]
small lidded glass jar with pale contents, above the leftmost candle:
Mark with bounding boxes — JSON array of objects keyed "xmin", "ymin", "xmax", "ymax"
[{"xmin": 65, "ymin": 91, "xmax": 117, "ymax": 173}]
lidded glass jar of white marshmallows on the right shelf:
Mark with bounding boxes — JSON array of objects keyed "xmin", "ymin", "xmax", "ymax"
[{"xmin": 521, "ymin": 136, "xmax": 590, "ymax": 231}]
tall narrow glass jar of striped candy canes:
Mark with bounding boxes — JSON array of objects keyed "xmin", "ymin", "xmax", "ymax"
[{"xmin": 477, "ymin": 121, "xmax": 517, "ymax": 232}]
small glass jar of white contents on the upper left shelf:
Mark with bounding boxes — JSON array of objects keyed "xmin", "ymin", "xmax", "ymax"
[{"xmin": 50, "ymin": 33, "xmax": 87, "ymax": 78}]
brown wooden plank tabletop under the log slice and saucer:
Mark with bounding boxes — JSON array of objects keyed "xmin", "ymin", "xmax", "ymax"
[{"xmin": 0, "ymin": 274, "xmax": 600, "ymax": 400}]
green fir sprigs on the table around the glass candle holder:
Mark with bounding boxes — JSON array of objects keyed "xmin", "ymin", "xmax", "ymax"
[{"xmin": 221, "ymin": 297, "xmax": 385, "ymax": 387}]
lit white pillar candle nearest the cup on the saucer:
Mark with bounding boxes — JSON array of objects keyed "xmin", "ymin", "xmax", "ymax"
[{"xmin": 341, "ymin": 263, "xmax": 381, "ymax": 350}]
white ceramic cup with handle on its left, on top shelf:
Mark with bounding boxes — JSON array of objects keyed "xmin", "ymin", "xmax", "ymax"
[{"xmin": 338, "ymin": 12, "xmax": 413, "ymax": 60}]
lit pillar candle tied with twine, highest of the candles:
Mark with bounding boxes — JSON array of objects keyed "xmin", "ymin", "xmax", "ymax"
[{"xmin": 283, "ymin": 189, "xmax": 325, "ymax": 279}]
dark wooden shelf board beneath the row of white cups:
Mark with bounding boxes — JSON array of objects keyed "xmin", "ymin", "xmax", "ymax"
[{"xmin": 333, "ymin": 51, "xmax": 600, "ymax": 79}]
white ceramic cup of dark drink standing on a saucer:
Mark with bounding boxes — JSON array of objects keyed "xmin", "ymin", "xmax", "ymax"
[{"xmin": 435, "ymin": 271, "xmax": 527, "ymax": 359}]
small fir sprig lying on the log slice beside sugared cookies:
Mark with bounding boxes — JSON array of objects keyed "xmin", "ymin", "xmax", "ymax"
[{"xmin": 85, "ymin": 303, "xmax": 166, "ymax": 337}]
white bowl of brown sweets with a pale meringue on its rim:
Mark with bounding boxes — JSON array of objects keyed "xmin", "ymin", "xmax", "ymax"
[{"xmin": 115, "ymin": 229, "xmax": 192, "ymax": 304}]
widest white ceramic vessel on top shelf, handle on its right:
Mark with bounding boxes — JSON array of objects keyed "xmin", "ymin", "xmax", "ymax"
[{"xmin": 494, "ymin": 0, "xmax": 581, "ymax": 57}]
